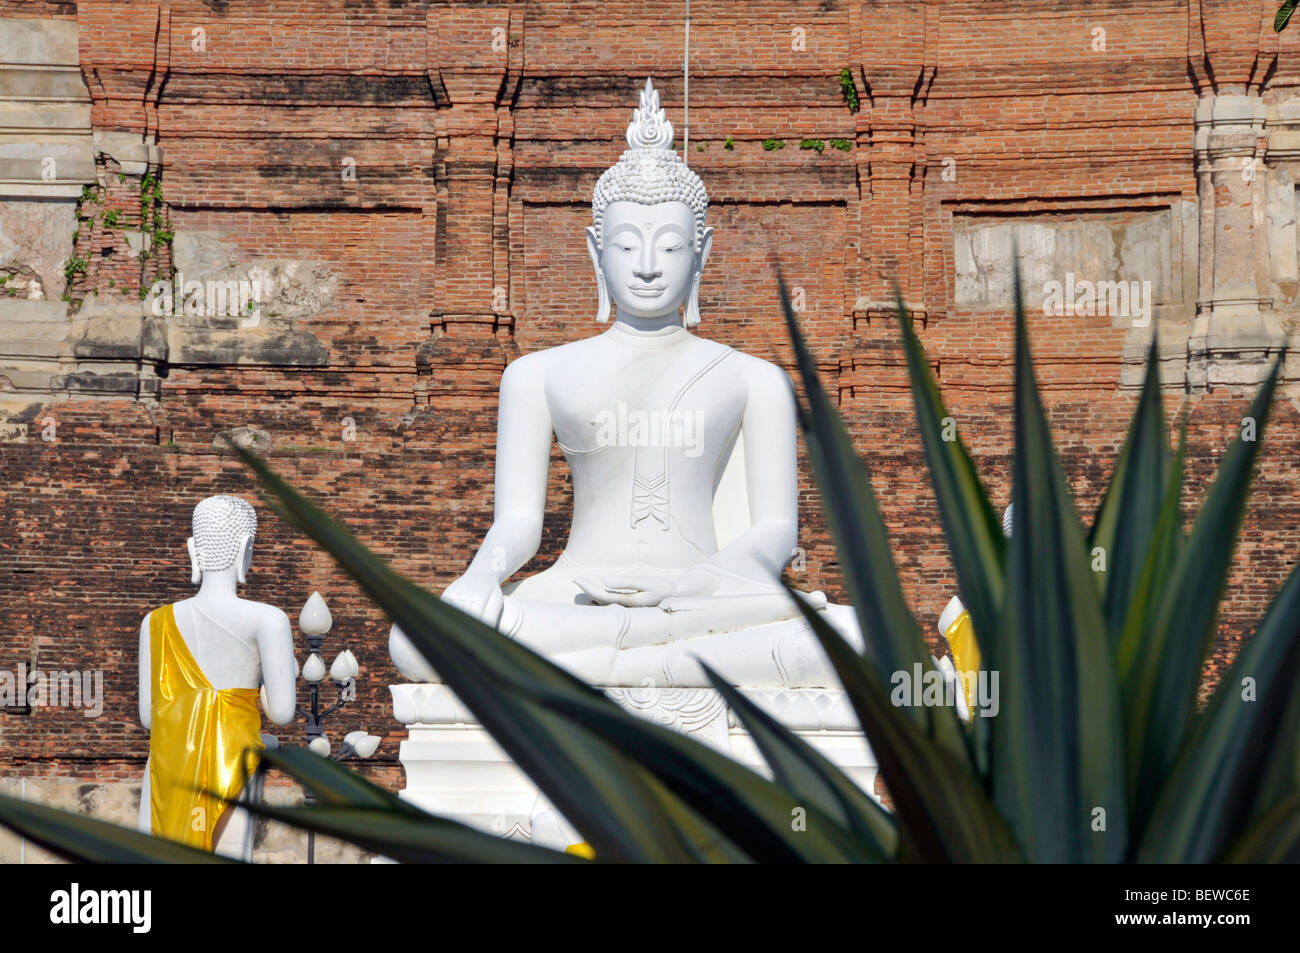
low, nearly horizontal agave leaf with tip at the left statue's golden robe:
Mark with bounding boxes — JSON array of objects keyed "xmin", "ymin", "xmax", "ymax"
[{"xmin": 237, "ymin": 800, "xmax": 588, "ymax": 863}]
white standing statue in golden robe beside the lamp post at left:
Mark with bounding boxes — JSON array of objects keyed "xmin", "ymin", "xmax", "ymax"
[{"xmin": 139, "ymin": 497, "xmax": 298, "ymax": 858}]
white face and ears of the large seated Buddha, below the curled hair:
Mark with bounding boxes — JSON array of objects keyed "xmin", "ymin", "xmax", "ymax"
[{"xmin": 588, "ymin": 202, "xmax": 712, "ymax": 320}]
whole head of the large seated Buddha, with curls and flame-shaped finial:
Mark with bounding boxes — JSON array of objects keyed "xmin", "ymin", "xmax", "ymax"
[{"xmin": 586, "ymin": 79, "xmax": 714, "ymax": 328}]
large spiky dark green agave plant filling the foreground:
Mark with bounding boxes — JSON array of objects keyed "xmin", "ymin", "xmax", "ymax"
[{"xmin": 0, "ymin": 276, "xmax": 1300, "ymax": 862}]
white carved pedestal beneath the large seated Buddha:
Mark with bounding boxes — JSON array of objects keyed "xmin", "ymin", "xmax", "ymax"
[{"xmin": 390, "ymin": 684, "xmax": 878, "ymax": 840}]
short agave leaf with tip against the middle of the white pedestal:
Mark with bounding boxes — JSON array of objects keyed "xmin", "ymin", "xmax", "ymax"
[{"xmin": 699, "ymin": 662, "xmax": 898, "ymax": 861}]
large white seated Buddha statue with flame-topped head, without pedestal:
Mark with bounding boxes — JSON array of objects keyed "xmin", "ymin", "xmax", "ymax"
[{"xmin": 389, "ymin": 79, "xmax": 862, "ymax": 688}]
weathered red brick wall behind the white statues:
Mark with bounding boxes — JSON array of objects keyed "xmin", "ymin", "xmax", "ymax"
[{"xmin": 0, "ymin": 0, "xmax": 1300, "ymax": 816}]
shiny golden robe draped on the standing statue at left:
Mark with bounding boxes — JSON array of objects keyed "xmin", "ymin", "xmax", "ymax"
[{"xmin": 150, "ymin": 606, "xmax": 261, "ymax": 850}]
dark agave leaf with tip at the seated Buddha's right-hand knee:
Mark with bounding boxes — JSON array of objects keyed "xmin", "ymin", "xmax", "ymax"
[{"xmin": 790, "ymin": 590, "xmax": 1022, "ymax": 863}]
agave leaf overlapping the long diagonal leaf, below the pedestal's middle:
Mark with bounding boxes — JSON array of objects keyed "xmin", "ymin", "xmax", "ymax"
[{"xmin": 542, "ymin": 676, "xmax": 884, "ymax": 863}]
